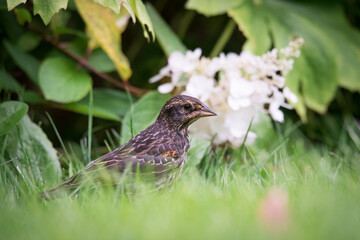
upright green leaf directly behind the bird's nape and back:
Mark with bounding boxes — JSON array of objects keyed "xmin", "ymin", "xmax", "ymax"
[{"xmin": 121, "ymin": 91, "xmax": 170, "ymax": 143}]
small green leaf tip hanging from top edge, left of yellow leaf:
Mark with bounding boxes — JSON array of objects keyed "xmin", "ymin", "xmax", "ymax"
[{"xmin": 33, "ymin": 0, "xmax": 68, "ymax": 25}]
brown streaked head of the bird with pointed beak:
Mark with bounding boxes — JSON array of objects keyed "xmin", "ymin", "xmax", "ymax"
[{"xmin": 157, "ymin": 95, "xmax": 216, "ymax": 129}]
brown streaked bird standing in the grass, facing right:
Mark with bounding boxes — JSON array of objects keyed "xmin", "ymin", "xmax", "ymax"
[{"xmin": 45, "ymin": 95, "xmax": 217, "ymax": 196}]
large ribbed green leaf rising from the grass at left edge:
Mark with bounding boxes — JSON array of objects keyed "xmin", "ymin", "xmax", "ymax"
[{"xmin": 0, "ymin": 116, "xmax": 61, "ymax": 186}]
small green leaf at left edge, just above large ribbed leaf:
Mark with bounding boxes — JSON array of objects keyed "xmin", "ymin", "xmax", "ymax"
[{"xmin": 0, "ymin": 101, "xmax": 29, "ymax": 136}]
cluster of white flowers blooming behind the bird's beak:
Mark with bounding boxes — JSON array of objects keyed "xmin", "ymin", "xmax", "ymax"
[{"xmin": 150, "ymin": 38, "xmax": 304, "ymax": 147}]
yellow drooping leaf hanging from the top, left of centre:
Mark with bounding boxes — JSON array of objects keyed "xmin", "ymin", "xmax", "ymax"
[{"xmin": 75, "ymin": 0, "xmax": 131, "ymax": 81}]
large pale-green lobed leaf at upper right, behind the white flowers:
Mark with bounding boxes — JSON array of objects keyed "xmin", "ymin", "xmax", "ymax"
[{"xmin": 187, "ymin": 0, "xmax": 360, "ymax": 120}]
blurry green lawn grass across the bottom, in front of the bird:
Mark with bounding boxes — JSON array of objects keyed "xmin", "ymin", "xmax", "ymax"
[{"xmin": 0, "ymin": 117, "xmax": 360, "ymax": 239}]
